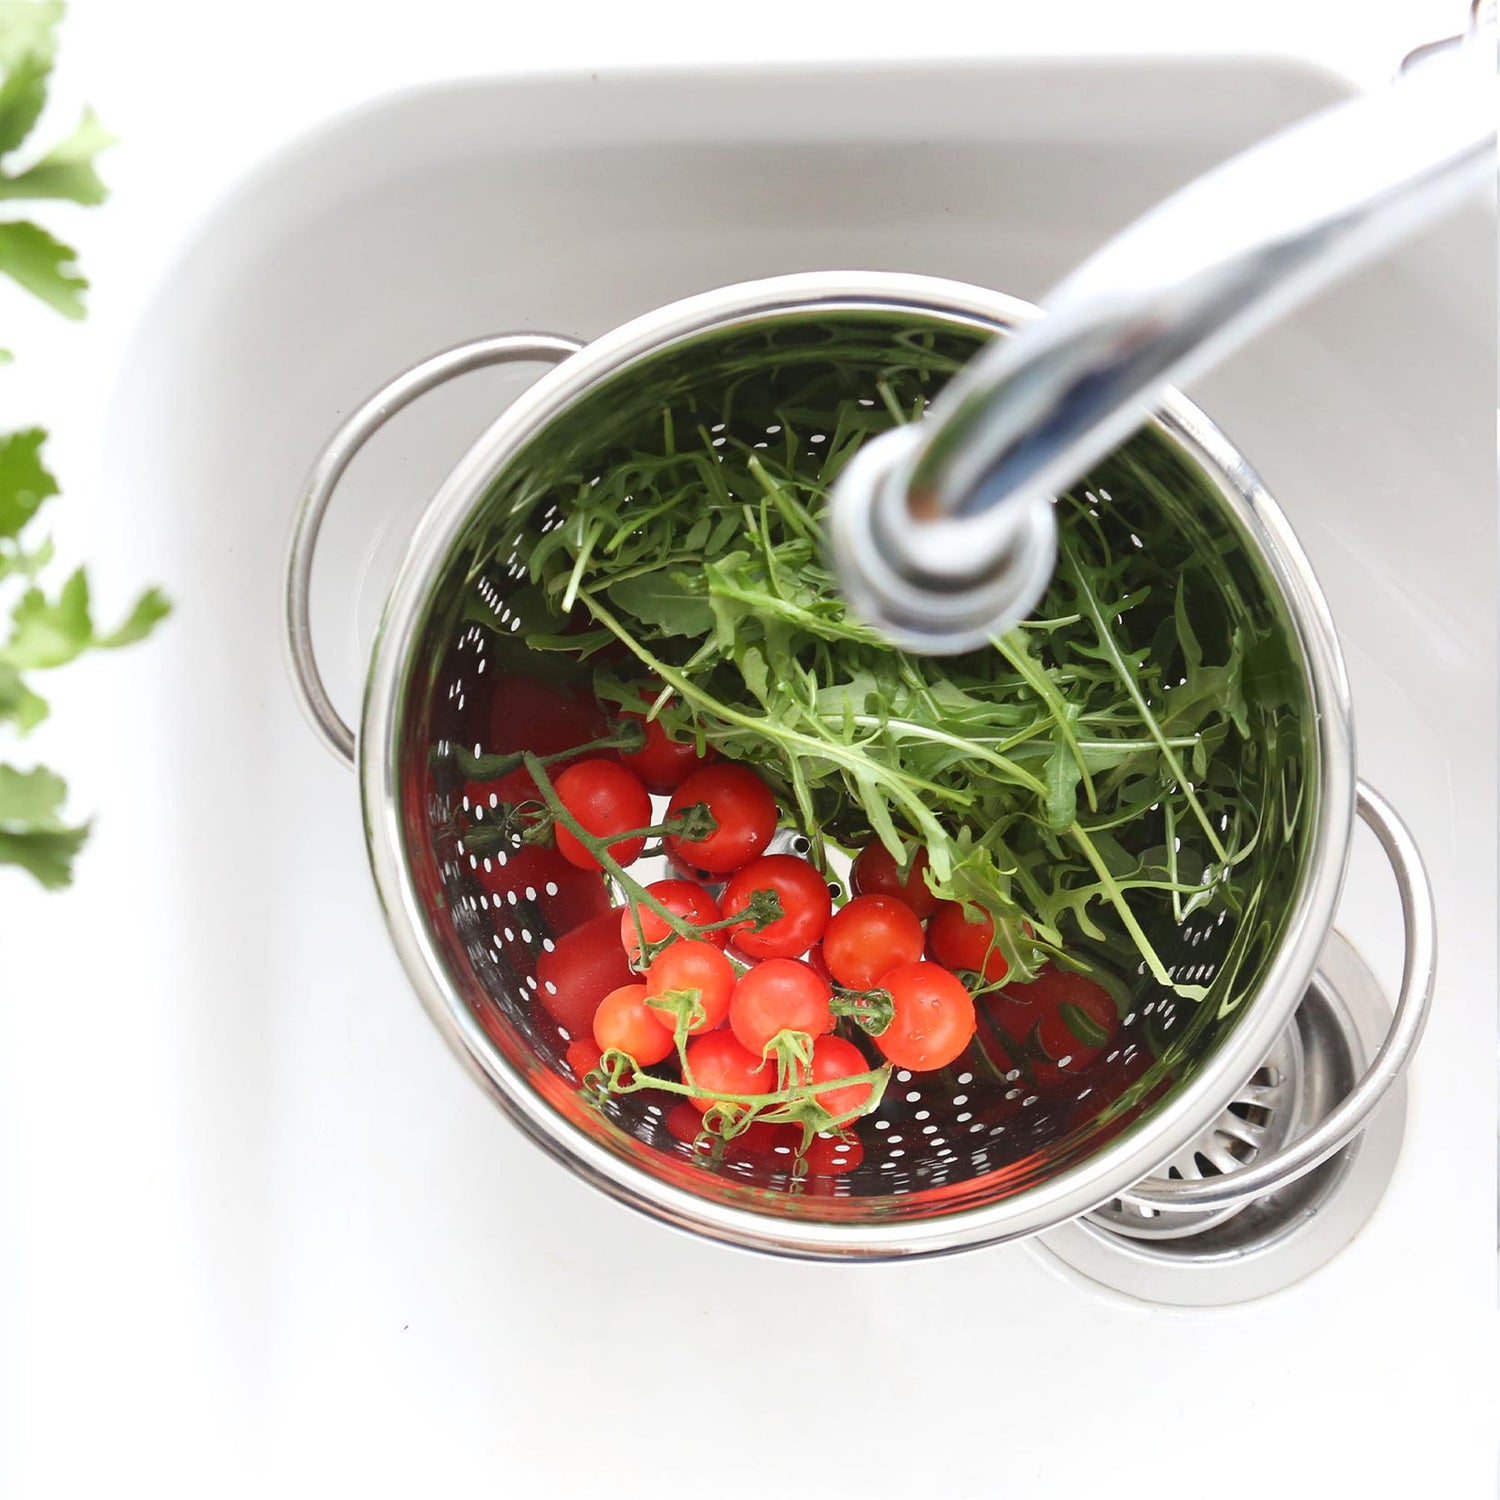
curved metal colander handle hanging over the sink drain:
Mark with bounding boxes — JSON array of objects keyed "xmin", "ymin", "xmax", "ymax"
[{"xmin": 1121, "ymin": 782, "xmax": 1437, "ymax": 1214}]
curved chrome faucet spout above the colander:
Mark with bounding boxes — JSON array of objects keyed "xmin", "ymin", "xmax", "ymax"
[{"xmin": 830, "ymin": 36, "xmax": 1496, "ymax": 654}]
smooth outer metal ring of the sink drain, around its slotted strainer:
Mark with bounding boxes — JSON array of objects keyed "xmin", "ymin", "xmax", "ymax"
[{"xmin": 1032, "ymin": 932, "xmax": 1407, "ymax": 1307}]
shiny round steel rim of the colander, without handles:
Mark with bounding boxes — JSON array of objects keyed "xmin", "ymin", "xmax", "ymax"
[{"xmin": 357, "ymin": 272, "xmax": 1356, "ymax": 1260}]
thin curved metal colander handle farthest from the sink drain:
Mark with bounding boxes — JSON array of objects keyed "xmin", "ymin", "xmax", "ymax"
[{"xmin": 287, "ymin": 333, "xmax": 584, "ymax": 765}]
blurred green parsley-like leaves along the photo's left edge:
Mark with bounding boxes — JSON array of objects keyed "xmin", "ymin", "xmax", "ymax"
[{"xmin": 0, "ymin": 0, "xmax": 170, "ymax": 888}]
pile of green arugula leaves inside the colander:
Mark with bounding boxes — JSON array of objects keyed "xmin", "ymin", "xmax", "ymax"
[{"xmin": 474, "ymin": 331, "xmax": 1298, "ymax": 999}]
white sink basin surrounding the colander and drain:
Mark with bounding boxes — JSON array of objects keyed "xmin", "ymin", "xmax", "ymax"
[{"xmin": 8, "ymin": 62, "xmax": 1497, "ymax": 1500}]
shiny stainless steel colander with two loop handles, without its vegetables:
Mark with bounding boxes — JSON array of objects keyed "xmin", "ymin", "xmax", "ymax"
[{"xmin": 288, "ymin": 273, "xmax": 1433, "ymax": 1259}]
